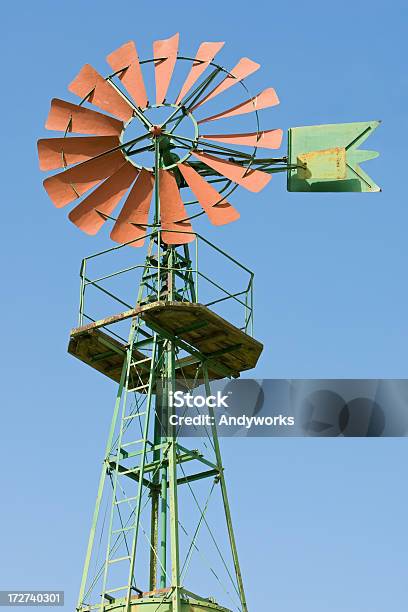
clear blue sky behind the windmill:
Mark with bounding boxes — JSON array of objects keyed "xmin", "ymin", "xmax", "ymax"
[{"xmin": 0, "ymin": 0, "xmax": 408, "ymax": 612}]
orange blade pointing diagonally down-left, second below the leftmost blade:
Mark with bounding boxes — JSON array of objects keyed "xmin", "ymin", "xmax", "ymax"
[{"xmin": 68, "ymin": 162, "xmax": 138, "ymax": 235}]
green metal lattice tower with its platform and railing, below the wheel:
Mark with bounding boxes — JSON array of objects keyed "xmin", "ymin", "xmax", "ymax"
[{"xmin": 69, "ymin": 230, "xmax": 262, "ymax": 611}]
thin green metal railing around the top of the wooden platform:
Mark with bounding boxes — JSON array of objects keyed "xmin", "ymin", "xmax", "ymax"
[{"xmin": 78, "ymin": 230, "xmax": 254, "ymax": 337}]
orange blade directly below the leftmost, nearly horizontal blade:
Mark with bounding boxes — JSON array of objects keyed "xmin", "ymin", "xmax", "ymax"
[{"xmin": 43, "ymin": 151, "xmax": 126, "ymax": 208}]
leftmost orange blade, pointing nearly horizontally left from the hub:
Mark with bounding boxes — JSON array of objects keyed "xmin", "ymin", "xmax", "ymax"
[{"xmin": 37, "ymin": 136, "xmax": 120, "ymax": 170}]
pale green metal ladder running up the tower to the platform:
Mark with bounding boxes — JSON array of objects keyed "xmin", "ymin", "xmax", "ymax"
[{"xmin": 100, "ymin": 319, "xmax": 158, "ymax": 611}]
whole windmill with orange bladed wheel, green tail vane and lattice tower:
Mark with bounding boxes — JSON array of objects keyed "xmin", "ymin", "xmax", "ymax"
[{"xmin": 38, "ymin": 34, "xmax": 379, "ymax": 612}]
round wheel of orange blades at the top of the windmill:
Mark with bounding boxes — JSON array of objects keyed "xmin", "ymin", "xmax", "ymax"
[{"xmin": 38, "ymin": 34, "xmax": 282, "ymax": 246}]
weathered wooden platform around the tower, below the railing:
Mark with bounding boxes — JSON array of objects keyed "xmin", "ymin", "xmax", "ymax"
[{"xmin": 68, "ymin": 302, "xmax": 263, "ymax": 386}]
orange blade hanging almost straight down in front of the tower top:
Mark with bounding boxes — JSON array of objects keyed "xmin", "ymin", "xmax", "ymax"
[{"xmin": 159, "ymin": 169, "xmax": 195, "ymax": 244}]
